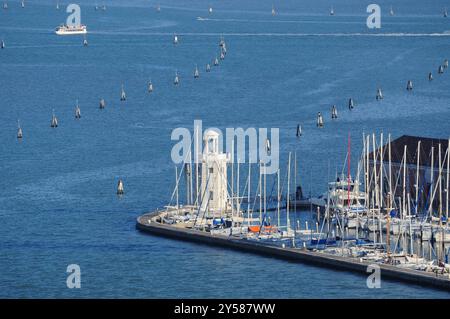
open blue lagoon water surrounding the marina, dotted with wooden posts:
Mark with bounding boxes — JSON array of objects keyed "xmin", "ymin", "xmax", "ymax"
[{"xmin": 0, "ymin": 0, "xmax": 450, "ymax": 298}]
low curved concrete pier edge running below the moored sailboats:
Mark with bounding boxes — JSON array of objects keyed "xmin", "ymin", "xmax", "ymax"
[{"xmin": 136, "ymin": 211, "xmax": 450, "ymax": 291}]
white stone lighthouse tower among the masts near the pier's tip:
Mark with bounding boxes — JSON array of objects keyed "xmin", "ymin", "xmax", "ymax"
[{"xmin": 200, "ymin": 130, "xmax": 229, "ymax": 215}]
